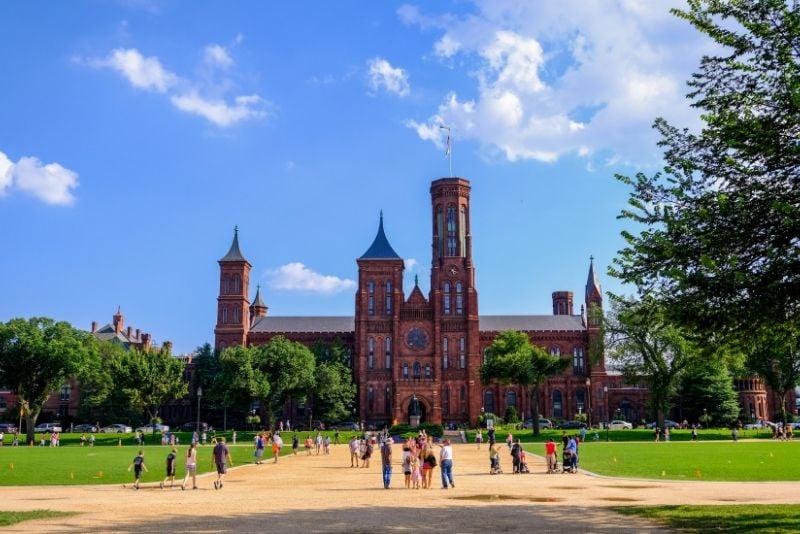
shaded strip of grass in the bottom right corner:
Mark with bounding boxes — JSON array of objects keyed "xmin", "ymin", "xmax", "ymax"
[{"xmin": 614, "ymin": 504, "xmax": 800, "ymax": 532}]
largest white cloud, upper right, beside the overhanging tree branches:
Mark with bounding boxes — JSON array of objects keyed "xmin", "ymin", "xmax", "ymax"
[{"xmin": 406, "ymin": 0, "xmax": 715, "ymax": 165}]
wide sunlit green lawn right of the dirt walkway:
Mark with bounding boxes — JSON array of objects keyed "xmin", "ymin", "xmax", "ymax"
[{"xmin": 525, "ymin": 440, "xmax": 800, "ymax": 481}]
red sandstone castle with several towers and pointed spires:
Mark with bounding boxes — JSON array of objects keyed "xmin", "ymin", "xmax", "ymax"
[{"xmin": 209, "ymin": 178, "xmax": 796, "ymax": 426}]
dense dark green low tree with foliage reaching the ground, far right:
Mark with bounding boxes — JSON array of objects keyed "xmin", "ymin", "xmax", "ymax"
[{"xmin": 676, "ymin": 358, "xmax": 739, "ymax": 426}]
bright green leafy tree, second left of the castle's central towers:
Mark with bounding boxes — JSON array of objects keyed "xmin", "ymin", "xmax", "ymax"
[{"xmin": 254, "ymin": 336, "xmax": 315, "ymax": 430}]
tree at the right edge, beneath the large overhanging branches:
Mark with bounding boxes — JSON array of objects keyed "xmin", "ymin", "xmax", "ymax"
[{"xmin": 747, "ymin": 329, "xmax": 800, "ymax": 422}]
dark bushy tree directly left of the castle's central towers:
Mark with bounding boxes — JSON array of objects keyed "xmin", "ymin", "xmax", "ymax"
[{"xmin": 310, "ymin": 340, "xmax": 356, "ymax": 422}]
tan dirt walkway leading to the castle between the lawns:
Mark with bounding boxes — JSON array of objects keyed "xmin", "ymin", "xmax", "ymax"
[{"xmin": 0, "ymin": 444, "xmax": 800, "ymax": 534}]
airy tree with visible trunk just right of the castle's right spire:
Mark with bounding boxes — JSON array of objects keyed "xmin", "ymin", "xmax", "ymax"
[{"xmin": 605, "ymin": 295, "xmax": 697, "ymax": 428}]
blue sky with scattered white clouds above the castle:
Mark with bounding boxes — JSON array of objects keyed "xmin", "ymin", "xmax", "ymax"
[{"xmin": 0, "ymin": 0, "xmax": 710, "ymax": 352}]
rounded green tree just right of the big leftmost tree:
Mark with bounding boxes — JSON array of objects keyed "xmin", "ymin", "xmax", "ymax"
[{"xmin": 112, "ymin": 347, "xmax": 188, "ymax": 430}]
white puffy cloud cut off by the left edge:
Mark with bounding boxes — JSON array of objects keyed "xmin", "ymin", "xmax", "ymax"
[{"xmin": 0, "ymin": 152, "xmax": 78, "ymax": 206}]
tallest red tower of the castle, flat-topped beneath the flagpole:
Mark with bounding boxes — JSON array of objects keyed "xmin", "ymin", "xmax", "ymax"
[{"xmin": 429, "ymin": 178, "xmax": 482, "ymax": 421}]
